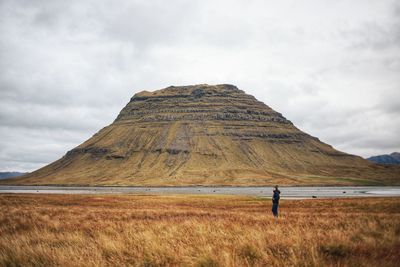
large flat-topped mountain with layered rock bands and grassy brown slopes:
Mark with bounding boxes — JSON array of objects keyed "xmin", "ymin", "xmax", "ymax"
[{"xmin": 3, "ymin": 84, "xmax": 400, "ymax": 185}]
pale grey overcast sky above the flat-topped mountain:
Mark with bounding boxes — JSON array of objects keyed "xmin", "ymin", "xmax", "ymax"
[{"xmin": 0, "ymin": 0, "xmax": 400, "ymax": 171}]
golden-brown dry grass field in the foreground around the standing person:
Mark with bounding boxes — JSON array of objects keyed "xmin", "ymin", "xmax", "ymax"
[{"xmin": 0, "ymin": 195, "xmax": 400, "ymax": 267}]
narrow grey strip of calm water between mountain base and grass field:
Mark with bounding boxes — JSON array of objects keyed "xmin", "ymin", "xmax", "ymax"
[{"xmin": 0, "ymin": 185, "xmax": 400, "ymax": 198}]
